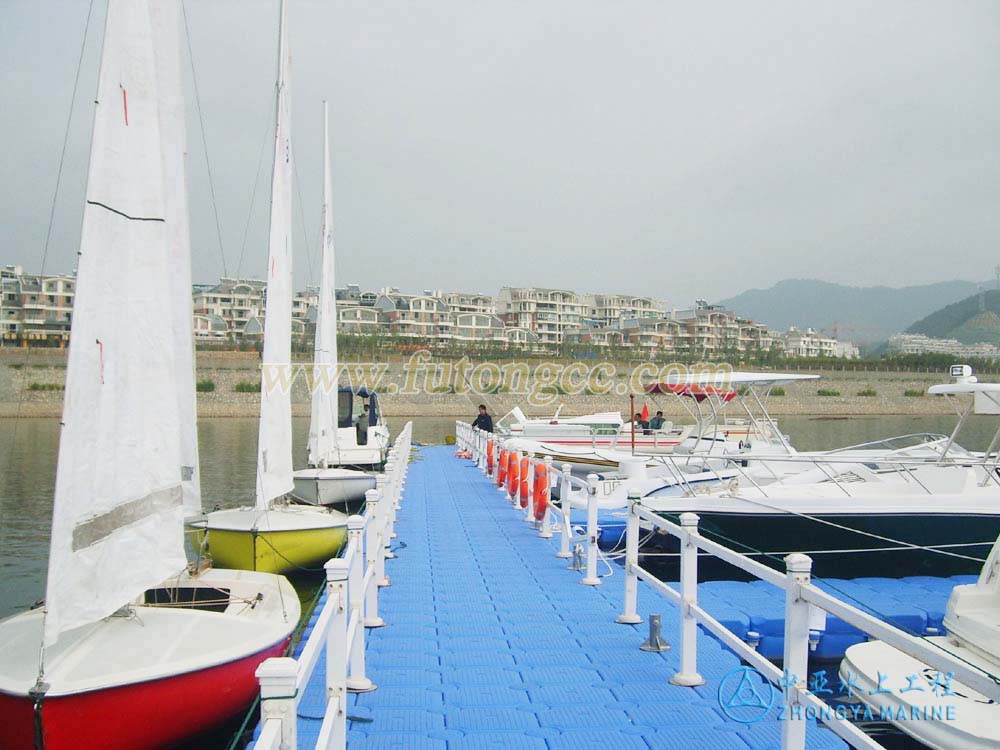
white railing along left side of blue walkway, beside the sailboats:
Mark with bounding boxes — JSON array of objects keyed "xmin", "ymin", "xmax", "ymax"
[{"xmin": 254, "ymin": 422, "xmax": 413, "ymax": 750}]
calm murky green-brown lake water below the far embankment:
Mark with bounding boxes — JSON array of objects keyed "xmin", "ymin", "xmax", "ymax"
[{"xmin": 0, "ymin": 415, "xmax": 996, "ymax": 617}]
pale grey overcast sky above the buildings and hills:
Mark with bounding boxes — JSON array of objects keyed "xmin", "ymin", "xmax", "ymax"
[{"xmin": 0, "ymin": 0, "xmax": 1000, "ymax": 304}]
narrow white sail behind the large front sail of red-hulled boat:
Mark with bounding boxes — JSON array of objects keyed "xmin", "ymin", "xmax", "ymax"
[{"xmin": 150, "ymin": 0, "xmax": 201, "ymax": 516}]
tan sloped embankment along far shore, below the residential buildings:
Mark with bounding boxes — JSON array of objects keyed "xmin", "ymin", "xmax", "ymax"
[{"xmin": 0, "ymin": 349, "xmax": 968, "ymax": 421}]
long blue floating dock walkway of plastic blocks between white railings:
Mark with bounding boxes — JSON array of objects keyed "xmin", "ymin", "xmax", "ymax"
[{"xmin": 260, "ymin": 446, "xmax": 860, "ymax": 750}]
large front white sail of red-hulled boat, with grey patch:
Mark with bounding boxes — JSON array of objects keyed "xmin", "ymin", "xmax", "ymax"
[{"xmin": 45, "ymin": 0, "xmax": 186, "ymax": 644}]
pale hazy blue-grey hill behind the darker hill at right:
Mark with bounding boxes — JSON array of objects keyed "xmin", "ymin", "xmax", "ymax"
[{"xmin": 719, "ymin": 279, "xmax": 978, "ymax": 344}]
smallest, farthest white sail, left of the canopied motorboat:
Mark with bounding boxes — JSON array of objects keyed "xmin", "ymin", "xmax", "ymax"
[{"xmin": 309, "ymin": 102, "xmax": 339, "ymax": 466}]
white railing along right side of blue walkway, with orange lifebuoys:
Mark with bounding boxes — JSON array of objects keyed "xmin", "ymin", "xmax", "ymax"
[{"xmin": 455, "ymin": 422, "xmax": 1000, "ymax": 750}]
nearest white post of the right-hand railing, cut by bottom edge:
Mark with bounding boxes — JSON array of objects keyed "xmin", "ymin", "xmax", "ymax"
[{"xmin": 781, "ymin": 552, "xmax": 812, "ymax": 750}]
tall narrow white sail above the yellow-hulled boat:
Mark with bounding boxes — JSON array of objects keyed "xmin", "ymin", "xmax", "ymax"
[{"xmin": 257, "ymin": 0, "xmax": 293, "ymax": 510}]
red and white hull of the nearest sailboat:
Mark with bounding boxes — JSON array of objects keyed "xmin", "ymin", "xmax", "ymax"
[{"xmin": 0, "ymin": 570, "xmax": 300, "ymax": 750}]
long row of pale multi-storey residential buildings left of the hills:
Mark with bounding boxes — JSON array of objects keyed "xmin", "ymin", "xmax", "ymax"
[{"xmin": 0, "ymin": 266, "xmax": 860, "ymax": 357}]
